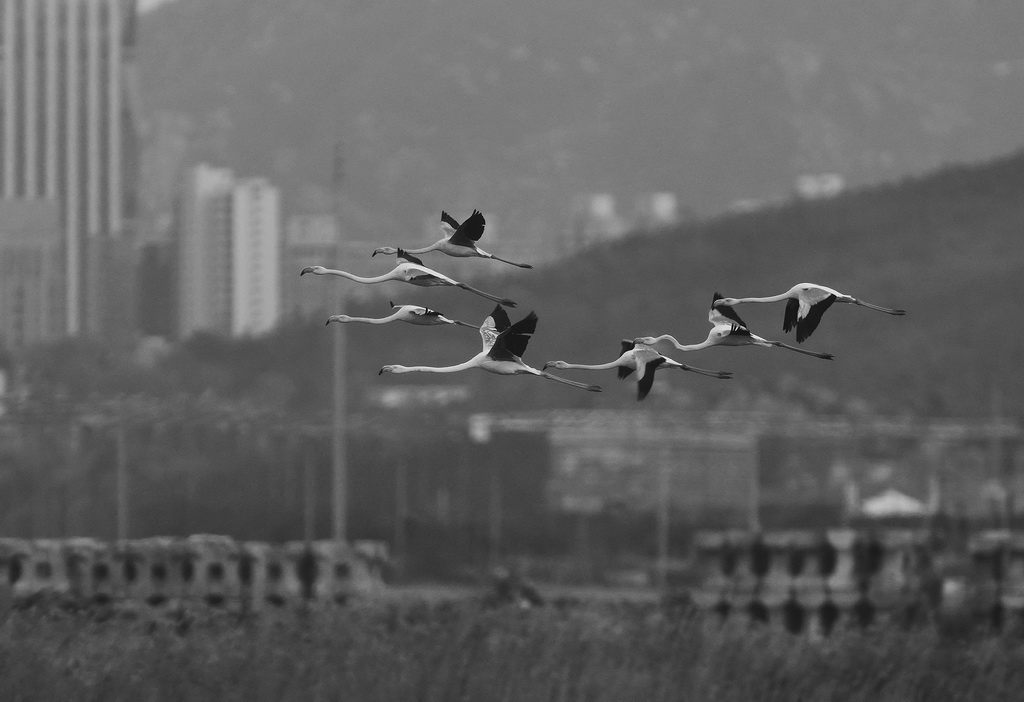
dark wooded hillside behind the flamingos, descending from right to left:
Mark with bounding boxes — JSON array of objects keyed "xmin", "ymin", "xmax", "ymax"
[{"xmin": 41, "ymin": 151, "xmax": 1024, "ymax": 418}]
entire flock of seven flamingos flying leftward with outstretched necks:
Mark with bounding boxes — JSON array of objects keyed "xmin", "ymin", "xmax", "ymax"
[{"xmin": 299, "ymin": 210, "xmax": 906, "ymax": 401}]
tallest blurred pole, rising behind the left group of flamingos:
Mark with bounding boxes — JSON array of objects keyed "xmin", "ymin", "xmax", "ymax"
[{"xmin": 331, "ymin": 142, "xmax": 348, "ymax": 541}]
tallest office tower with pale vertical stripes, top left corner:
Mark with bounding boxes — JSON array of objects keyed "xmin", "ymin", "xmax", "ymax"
[{"xmin": 0, "ymin": 0, "xmax": 137, "ymax": 336}]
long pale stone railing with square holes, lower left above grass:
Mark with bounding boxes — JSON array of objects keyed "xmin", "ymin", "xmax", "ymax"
[{"xmin": 0, "ymin": 534, "xmax": 387, "ymax": 610}]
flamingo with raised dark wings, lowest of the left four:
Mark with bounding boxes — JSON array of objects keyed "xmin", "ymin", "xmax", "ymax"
[{"xmin": 377, "ymin": 305, "xmax": 601, "ymax": 392}]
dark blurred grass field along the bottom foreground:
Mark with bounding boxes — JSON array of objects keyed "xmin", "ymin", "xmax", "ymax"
[{"xmin": 0, "ymin": 600, "xmax": 1024, "ymax": 702}]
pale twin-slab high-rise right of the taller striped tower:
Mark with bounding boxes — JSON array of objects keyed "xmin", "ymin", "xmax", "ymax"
[{"xmin": 177, "ymin": 164, "xmax": 281, "ymax": 338}]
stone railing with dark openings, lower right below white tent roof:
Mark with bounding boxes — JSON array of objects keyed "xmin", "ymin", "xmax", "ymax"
[{"xmin": 690, "ymin": 529, "xmax": 954, "ymax": 634}]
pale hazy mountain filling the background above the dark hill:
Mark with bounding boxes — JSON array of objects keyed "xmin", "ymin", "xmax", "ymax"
[{"xmin": 138, "ymin": 0, "xmax": 1024, "ymax": 253}]
